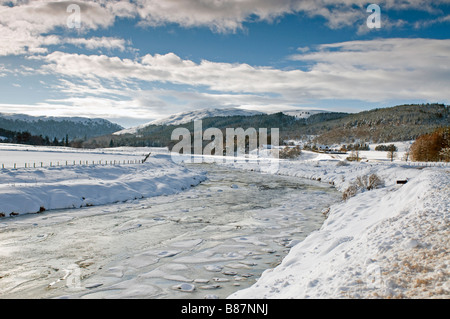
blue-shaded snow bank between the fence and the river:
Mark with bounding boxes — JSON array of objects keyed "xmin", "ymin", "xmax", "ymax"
[{"xmin": 0, "ymin": 155, "xmax": 205, "ymax": 216}]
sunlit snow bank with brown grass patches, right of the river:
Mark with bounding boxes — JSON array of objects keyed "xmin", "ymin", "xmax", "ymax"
[{"xmin": 229, "ymin": 155, "xmax": 450, "ymax": 299}]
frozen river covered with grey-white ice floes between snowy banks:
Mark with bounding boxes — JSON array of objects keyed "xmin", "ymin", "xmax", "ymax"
[{"xmin": 0, "ymin": 164, "xmax": 340, "ymax": 299}]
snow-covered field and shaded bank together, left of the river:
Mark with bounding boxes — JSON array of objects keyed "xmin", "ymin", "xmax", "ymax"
[{"xmin": 0, "ymin": 145, "xmax": 205, "ymax": 216}]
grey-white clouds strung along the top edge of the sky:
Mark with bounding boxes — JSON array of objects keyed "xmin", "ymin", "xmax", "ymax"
[{"xmin": 0, "ymin": 0, "xmax": 450, "ymax": 56}]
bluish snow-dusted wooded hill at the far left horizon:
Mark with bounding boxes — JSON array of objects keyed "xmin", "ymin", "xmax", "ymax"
[{"xmin": 0, "ymin": 113, "xmax": 123, "ymax": 140}]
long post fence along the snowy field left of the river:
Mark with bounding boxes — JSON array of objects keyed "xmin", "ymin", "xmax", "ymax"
[{"xmin": 1, "ymin": 159, "xmax": 145, "ymax": 169}]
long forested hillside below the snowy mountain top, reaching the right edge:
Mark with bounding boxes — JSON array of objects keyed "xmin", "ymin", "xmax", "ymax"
[{"xmin": 79, "ymin": 104, "xmax": 450, "ymax": 147}]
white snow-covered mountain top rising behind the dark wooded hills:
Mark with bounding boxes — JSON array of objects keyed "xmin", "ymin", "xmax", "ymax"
[{"xmin": 114, "ymin": 108, "xmax": 265, "ymax": 135}]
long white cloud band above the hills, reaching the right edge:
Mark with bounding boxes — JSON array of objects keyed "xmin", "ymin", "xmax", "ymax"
[{"xmin": 37, "ymin": 39, "xmax": 450, "ymax": 102}]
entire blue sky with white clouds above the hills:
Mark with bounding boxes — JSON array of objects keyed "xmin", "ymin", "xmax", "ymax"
[{"xmin": 0, "ymin": 0, "xmax": 450, "ymax": 127}]
